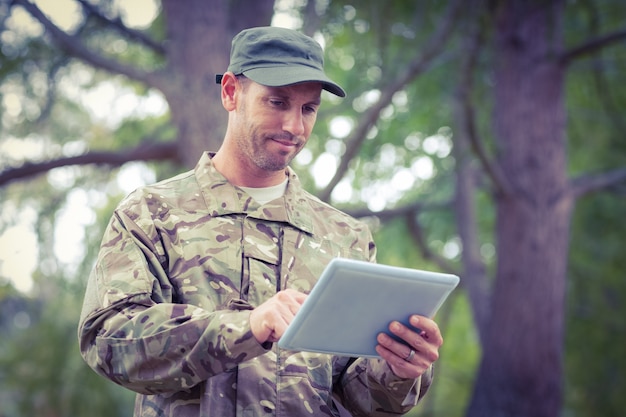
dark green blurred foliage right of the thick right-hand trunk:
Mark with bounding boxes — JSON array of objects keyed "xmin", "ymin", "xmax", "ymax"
[{"xmin": 563, "ymin": 1, "xmax": 626, "ymax": 417}]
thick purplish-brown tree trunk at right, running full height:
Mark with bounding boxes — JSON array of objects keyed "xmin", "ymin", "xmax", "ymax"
[{"xmin": 467, "ymin": 0, "xmax": 572, "ymax": 417}]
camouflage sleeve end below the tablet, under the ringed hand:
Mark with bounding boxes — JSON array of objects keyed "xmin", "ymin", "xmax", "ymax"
[{"xmin": 336, "ymin": 358, "xmax": 433, "ymax": 417}]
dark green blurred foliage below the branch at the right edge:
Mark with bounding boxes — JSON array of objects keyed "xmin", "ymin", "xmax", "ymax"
[{"xmin": 565, "ymin": 190, "xmax": 626, "ymax": 417}]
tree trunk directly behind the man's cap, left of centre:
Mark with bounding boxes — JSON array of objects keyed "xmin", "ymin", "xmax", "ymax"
[{"xmin": 162, "ymin": 0, "xmax": 274, "ymax": 167}]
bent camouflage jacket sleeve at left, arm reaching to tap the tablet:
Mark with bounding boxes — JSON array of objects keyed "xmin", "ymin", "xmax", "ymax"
[{"xmin": 78, "ymin": 207, "xmax": 271, "ymax": 394}]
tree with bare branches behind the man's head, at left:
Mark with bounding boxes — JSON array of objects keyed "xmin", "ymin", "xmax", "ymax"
[{"xmin": 3, "ymin": 0, "xmax": 273, "ymax": 181}]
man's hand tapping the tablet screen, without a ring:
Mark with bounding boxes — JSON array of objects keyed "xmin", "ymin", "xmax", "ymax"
[{"xmin": 250, "ymin": 288, "xmax": 307, "ymax": 343}]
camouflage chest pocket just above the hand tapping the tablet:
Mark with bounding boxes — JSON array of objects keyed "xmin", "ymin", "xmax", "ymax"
[{"xmin": 240, "ymin": 218, "xmax": 283, "ymax": 307}]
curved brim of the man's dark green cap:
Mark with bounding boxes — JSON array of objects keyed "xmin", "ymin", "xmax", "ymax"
[{"xmin": 243, "ymin": 66, "xmax": 346, "ymax": 97}]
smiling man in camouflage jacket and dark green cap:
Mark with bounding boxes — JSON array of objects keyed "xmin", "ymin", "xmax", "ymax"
[{"xmin": 79, "ymin": 27, "xmax": 442, "ymax": 417}]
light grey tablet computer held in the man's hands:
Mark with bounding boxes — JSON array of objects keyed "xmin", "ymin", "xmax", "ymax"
[{"xmin": 278, "ymin": 258, "xmax": 459, "ymax": 357}]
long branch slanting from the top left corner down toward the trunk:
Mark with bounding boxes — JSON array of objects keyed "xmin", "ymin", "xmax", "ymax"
[{"xmin": 13, "ymin": 0, "xmax": 161, "ymax": 88}]
